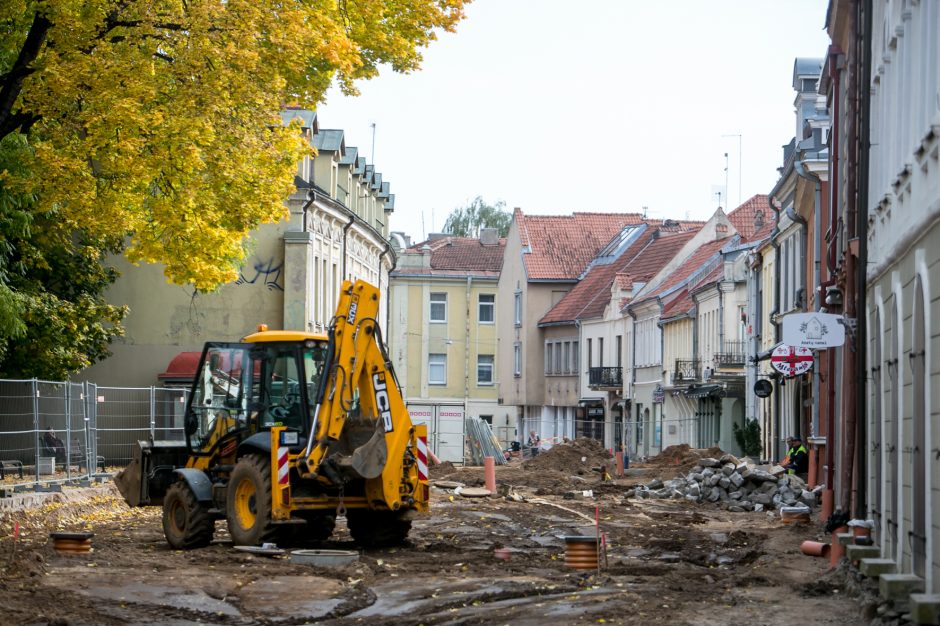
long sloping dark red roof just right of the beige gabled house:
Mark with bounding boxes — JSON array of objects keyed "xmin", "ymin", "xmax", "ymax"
[{"xmin": 539, "ymin": 227, "xmax": 696, "ymax": 324}]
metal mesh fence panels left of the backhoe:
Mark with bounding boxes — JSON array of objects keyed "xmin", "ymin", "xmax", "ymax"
[{"xmin": 0, "ymin": 380, "xmax": 188, "ymax": 486}]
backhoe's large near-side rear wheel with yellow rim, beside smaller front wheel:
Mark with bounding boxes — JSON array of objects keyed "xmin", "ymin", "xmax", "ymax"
[{"xmin": 225, "ymin": 454, "xmax": 277, "ymax": 546}]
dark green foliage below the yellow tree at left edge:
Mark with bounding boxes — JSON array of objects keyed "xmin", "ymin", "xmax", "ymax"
[{"xmin": 0, "ymin": 135, "xmax": 125, "ymax": 380}]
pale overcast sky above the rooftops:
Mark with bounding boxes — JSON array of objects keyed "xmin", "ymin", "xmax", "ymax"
[{"xmin": 318, "ymin": 0, "xmax": 828, "ymax": 241}]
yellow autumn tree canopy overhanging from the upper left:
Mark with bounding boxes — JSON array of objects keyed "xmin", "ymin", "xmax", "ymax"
[{"xmin": 0, "ymin": 0, "xmax": 469, "ymax": 288}]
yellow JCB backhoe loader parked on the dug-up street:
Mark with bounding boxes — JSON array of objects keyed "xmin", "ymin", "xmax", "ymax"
[{"xmin": 115, "ymin": 281, "xmax": 428, "ymax": 549}]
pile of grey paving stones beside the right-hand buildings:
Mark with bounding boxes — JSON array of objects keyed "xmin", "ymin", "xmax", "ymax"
[{"xmin": 626, "ymin": 454, "xmax": 822, "ymax": 513}]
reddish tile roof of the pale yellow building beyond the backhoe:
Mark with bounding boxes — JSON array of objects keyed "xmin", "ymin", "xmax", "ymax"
[{"xmin": 393, "ymin": 236, "xmax": 506, "ymax": 276}]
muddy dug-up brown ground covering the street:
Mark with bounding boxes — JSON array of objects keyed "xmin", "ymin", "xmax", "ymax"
[{"xmin": 0, "ymin": 440, "xmax": 867, "ymax": 626}]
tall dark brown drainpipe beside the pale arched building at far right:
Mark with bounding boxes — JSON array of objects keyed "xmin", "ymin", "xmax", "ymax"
[{"xmin": 855, "ymin": 0, "xmax": 872, "ymax": 518}]
